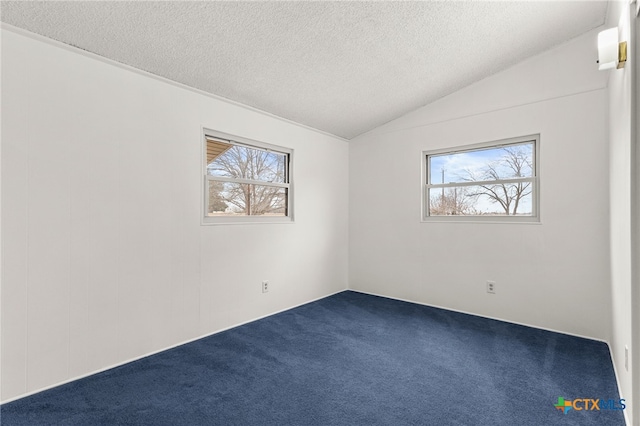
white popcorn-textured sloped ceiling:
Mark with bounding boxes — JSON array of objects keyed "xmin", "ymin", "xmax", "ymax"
[{"xmin": 1, "ymin": 1, "xmax": 607, "ymax": 139}]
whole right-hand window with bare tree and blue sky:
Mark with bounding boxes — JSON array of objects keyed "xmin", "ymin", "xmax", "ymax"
[{"xmin": 423, "ymin": 135, "xmax": 540, "ymax": 222}]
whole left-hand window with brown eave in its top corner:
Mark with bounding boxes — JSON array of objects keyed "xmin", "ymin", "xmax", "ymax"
[{"xmin": 203, "ymin": 130, "xmax": 293, "ymax": 223}]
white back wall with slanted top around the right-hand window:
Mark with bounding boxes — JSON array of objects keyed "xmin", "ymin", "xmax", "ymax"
[{"xmin": 349, "ymin": 31, "xmax": 611, "ymax": 340}]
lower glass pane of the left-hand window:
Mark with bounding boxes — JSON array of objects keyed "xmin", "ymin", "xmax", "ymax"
[{"xmin": 207, "ymin": 180, "xmax": 288, "ymax": 216}]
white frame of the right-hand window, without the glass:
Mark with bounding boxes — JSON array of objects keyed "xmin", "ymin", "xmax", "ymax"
[{"xmin": 422, "ymin": 134, "xmax": 541, "ymax": 224}]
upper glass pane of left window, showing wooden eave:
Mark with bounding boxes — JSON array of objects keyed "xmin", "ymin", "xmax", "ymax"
[{"xmin": 207, "ymin": 140, "xmax": 287, "ymax": 183}]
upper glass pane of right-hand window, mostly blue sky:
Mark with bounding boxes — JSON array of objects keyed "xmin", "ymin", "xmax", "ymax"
[{"xmin": 428, "ymin": 142, "xmax": 535, "ymax": 184}]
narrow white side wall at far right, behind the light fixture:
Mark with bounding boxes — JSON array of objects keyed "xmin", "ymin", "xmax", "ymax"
[{"xmin": 606, "ymin": 1, "xmax": 640, "ymax": 424}]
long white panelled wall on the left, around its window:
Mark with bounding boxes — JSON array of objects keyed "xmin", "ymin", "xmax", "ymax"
[{"xmin": 1, "ymin": 29, "xmax": 348, "ymax": 401}]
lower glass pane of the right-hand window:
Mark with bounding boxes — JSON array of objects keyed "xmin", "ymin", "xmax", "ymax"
[{"xmin": 429, "ymin": 182, "xmax": 533, "ymax": 216}]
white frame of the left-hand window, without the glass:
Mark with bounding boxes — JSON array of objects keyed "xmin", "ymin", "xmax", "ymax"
[{"xmin": 200, "ymin": 128, "xmax": 293, "ymax": 225}]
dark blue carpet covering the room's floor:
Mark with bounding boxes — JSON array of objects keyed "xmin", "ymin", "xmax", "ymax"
[{"xmin": 1, "ymin": 291, "xmax": 624, "ymax": 426}]
